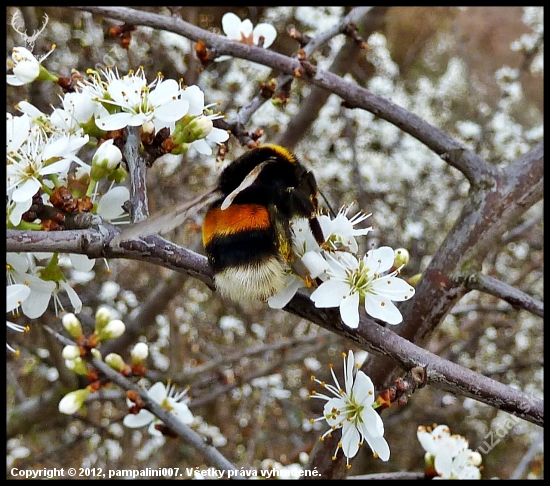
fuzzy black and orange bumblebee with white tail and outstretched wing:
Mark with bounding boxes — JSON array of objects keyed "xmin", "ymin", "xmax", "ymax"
[{"xmin": 114, "ymin": 144, "xmax": 324, "ymax": 302}]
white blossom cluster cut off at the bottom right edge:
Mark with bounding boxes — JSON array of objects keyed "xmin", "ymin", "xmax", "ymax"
[{"xmin": 416, "ymin": 425, "xmax": 481, "ymax": 479}]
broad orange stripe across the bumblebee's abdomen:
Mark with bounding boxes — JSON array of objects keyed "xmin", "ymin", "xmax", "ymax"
[{"xmin": 202, "ymin": 204, "xmax": 271, "ymax": 246}]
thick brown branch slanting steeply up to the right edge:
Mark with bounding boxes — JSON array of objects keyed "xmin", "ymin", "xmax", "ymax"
[{"xmin": 363, "ymin": 143, "xmax": 544, "ymax": 394}]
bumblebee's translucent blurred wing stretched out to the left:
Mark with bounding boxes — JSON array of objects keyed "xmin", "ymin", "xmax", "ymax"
[{"xmin": 111, "ymin": 189, "xmax": 222, "ymax": 245}]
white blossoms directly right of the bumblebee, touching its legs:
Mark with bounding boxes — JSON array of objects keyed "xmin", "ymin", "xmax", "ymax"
[{"xmin": 268, "ymin": 205, "xmax": 415, "ymax": 328}]
